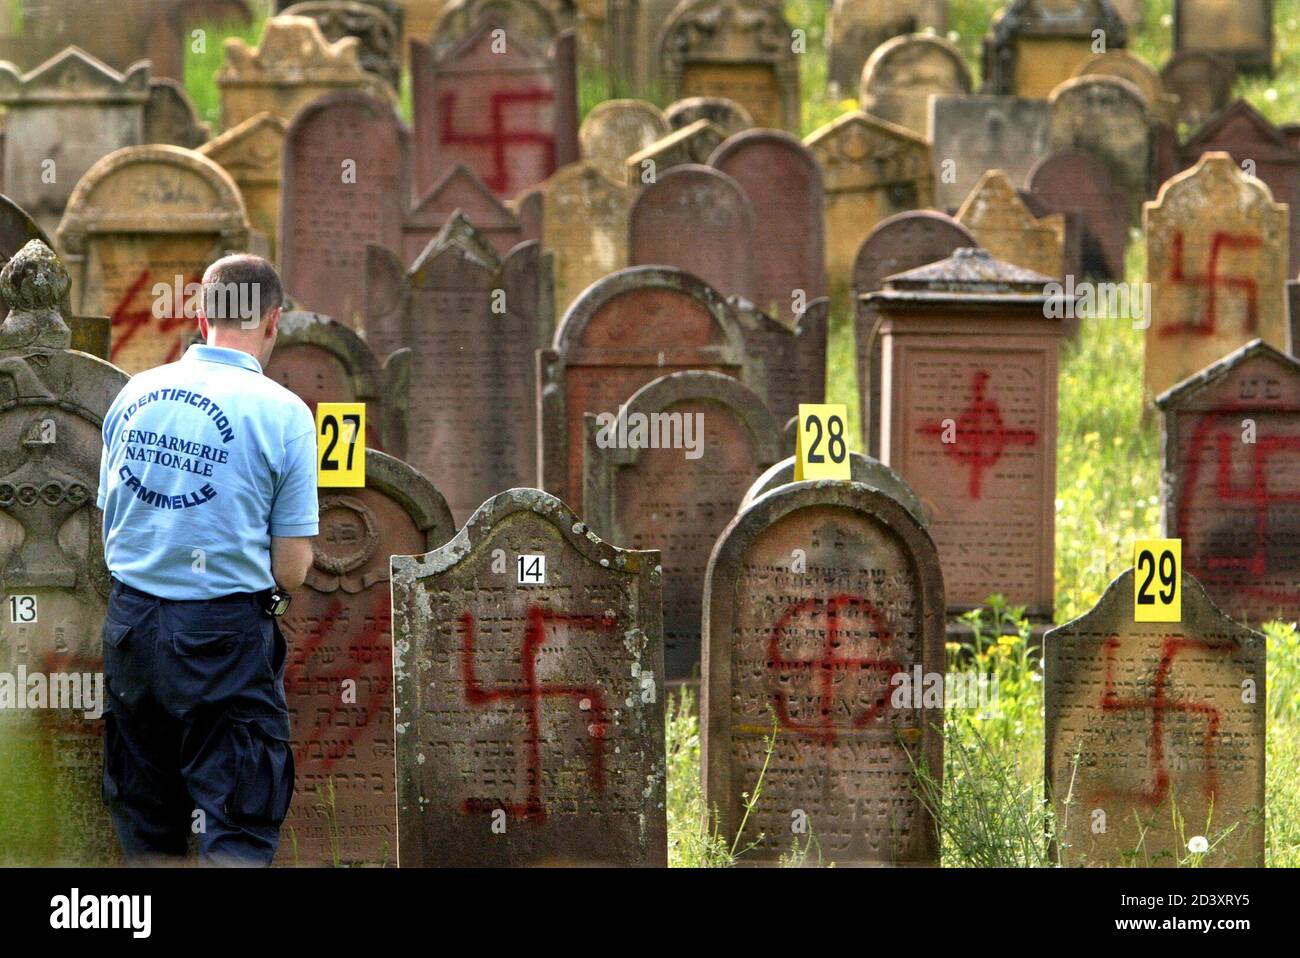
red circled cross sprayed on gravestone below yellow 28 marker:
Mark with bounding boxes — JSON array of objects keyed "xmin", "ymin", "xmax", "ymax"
[{"xmin": 767, "ymin": 594, "xmax": 901, "ymax": 745}]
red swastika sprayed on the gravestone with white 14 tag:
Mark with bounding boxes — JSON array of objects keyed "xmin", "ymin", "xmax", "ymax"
[{"xmin": 460, "ymin": 606, "xmax": 616, "ymax": 822}]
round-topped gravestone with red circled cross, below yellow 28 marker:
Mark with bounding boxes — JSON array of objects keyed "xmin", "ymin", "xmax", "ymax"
[{"xmin": 699, "ymin": 481, "xmax": 944, "ymax": 866}]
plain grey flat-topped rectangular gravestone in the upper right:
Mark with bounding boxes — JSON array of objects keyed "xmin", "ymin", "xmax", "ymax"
[{"xmin": 928, "ymin": 95, "xmax": 1050, "ymax": 209}]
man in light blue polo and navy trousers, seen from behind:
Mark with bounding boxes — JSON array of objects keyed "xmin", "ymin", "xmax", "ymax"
[{"xmin": 99, "ymin": 255, "xmax": 319, "ymax": 864}]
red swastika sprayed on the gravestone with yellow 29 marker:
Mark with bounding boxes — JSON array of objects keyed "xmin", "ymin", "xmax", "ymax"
[{"xmin": 1099, "ymin": 636, "xmax": 1232, "ymax": 806}]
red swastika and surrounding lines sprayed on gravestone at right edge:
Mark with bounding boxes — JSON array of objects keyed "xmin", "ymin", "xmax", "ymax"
[{"xmin": 1178, "ymin": 406, "xmax": 1300, "ymax": 606}]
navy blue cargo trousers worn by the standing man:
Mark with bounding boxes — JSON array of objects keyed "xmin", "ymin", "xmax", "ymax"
[{"xmin": 104, "ymin": 582, "xmax": 294, "ymax": 866}]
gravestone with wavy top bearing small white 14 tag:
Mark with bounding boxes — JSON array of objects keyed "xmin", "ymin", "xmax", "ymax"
[{"xmin": 393, "ymin": 489, "xmax": 668, "ymax": 868}]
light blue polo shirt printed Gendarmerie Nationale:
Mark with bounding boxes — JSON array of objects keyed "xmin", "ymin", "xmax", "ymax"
[{"xmin": 99, "ymin": 346, "xmax": 320, "ymax": 599}]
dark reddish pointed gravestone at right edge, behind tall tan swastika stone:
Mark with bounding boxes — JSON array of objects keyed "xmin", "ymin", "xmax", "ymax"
[{"xmin": 1182, "ymin": 100, "xmax": 1300, "ymax": 273}]
